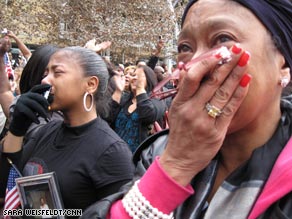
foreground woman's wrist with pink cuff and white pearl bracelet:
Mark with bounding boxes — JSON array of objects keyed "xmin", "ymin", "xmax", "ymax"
[{"xmin": 122, "ymin": 157, "xmax": 194, "ymax": 218}]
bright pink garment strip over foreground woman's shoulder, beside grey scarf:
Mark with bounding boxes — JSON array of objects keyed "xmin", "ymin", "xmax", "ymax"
[{"xmin": 248, "ymin": 138, "xmax": 292, "ymax": 219}]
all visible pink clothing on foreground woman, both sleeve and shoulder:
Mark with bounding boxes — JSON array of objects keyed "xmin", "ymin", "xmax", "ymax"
[{"xmin": 107, "ymin": 138, "xmax": 292, "ymax": 219}]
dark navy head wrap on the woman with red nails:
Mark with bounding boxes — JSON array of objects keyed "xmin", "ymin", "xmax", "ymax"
[{"xmin": 182, "ymin": 0, "xmax": 292, "ymax": 72}]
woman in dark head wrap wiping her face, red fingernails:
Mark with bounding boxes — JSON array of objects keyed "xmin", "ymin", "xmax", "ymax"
[{"xmin": 81, "ymin": 0, "xmax": 292, "ymax": 219}]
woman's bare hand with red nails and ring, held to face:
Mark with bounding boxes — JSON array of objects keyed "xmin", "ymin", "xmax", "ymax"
[{"xmin": 160, "ymin": 45, "xmax": 251, "ymax": 185}]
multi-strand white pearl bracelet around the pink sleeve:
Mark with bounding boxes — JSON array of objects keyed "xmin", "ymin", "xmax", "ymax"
[{"xmin": 122, "ymin": 180, "xmax": 173, "ymax": 219}]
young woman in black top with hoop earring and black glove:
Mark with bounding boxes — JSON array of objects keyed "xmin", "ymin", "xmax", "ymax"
[{"xmin": 2, "ymin": 47, "xmax": 133, "ymax": 214}]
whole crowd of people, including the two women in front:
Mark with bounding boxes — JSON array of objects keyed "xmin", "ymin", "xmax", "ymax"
[{"xmin": 0, "ymin": 0, "xmax": 292, "ymax": 219}]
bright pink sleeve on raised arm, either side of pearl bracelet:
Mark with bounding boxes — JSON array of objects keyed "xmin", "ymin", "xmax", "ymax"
[{"xmin": 107, "ymin": 157, "xmax": 194, "ymax": 219}]
